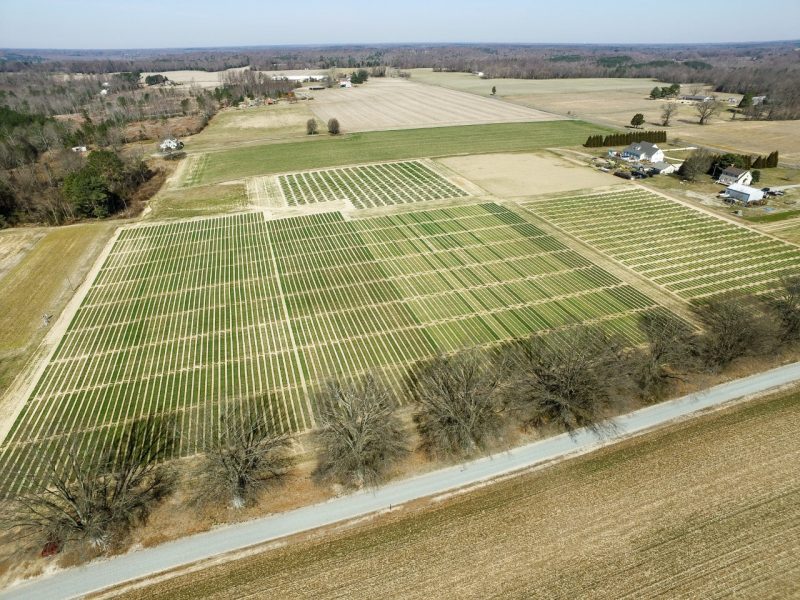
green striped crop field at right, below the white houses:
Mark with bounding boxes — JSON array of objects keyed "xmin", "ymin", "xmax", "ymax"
[{"xmin": 524, "ymin": 189, "xmax": 800, "ymax": 300}]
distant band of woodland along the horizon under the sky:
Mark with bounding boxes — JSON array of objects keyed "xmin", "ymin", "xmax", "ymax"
[{"xmin": 0, "ymin": 42, "xmax": 800, "ymax": 119}]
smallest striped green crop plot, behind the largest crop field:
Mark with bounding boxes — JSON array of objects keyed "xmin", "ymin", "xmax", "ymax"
[{"xmin": 278, "ymin": 161, "xmax": 468, "ymax": 208}]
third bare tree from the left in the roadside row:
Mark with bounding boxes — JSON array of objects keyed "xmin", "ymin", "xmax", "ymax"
[{"xmin": 314, "ymin": 375, "xmax": 408, "ymax": 488}]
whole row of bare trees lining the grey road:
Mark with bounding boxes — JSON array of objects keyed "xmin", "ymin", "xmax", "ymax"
[{"xmin": 4, "ymin": 276, "xmax": 800, "ymax": 551}]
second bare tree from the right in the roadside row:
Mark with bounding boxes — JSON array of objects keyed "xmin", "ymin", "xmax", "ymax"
[{"xmin": 694, "ymin": 294, "xmax": 779, "ymax": 370}]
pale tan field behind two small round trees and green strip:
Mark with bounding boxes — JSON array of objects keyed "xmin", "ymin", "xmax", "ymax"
[{"xmin": 311, "ymin": 79, "xmax": 561, "ymax": 131}]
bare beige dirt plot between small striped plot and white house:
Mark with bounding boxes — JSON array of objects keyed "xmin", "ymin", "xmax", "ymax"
[{"xmin": 438, "ymin": 153, "xmax": 622, "ymax": 198}]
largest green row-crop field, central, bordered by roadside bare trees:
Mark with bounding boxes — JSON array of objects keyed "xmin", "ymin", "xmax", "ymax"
[{"xmin": 0, "ymin": 204, "xmax": 663, "ymax": 492}]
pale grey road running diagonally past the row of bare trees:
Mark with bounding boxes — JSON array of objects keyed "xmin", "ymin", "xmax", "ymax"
[{"xmin": 0, "ymin": 363, "xmax": 800, "ymax": 600}]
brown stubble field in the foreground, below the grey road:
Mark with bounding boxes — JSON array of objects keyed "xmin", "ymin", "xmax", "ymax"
[{"xmin": 117, "ymin": 391, "xmax": 800, "ymax": 599}]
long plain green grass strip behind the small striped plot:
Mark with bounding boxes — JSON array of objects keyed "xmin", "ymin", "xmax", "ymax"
[{"xmin": 197, "ymin": 121, "xmax": 610, "ymax": 184}]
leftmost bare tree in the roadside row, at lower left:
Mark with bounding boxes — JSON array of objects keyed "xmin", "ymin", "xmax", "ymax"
[{"xmin": 6, "ymin": 417, "xmax": 177, "ymax": 549}]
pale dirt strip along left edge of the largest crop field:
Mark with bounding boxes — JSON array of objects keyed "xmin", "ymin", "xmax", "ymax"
[{"xmin": 0, "ymin": 227, "xmax": 123, "ymax": 448}]
